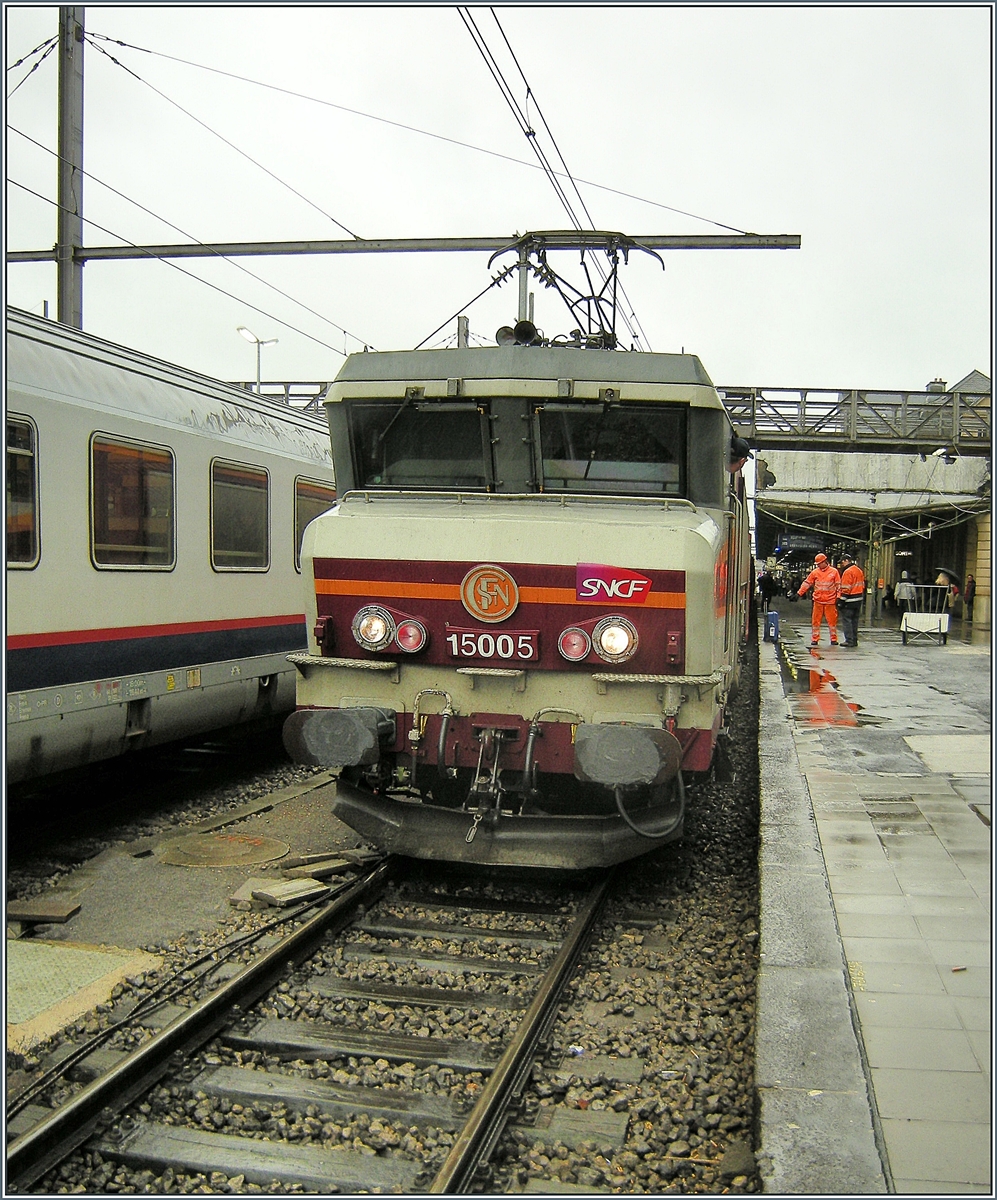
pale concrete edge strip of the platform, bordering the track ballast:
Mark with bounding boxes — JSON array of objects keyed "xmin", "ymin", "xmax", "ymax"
[{"xmin": 755, "ymin": 642, "xmax": 893, "ymax": 1195}]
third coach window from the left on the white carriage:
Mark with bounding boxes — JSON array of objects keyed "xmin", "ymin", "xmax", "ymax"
[{"xmin": 211, "ymin": 460, "xmax": 270, "ymax": 571}]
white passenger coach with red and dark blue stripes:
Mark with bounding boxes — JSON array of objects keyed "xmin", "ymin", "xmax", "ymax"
[{"xmin": 6, "ymin": 310, "xmax": 336, "ymax": 782}]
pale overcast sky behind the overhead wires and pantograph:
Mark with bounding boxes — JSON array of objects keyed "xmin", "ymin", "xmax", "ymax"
[{"xmin": 5, "ymin": 4, "xmax": 993, "ymax": 389}]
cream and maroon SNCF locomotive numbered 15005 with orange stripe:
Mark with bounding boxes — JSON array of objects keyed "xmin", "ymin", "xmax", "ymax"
[{"xmin": 284, "ymin": 322, "xmax": 751, "ymax": 869}]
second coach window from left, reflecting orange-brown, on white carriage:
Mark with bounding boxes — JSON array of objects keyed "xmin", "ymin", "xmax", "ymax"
[{"xmin": 90, "ymin": 433, "xmax": 175, "ymax": 570}]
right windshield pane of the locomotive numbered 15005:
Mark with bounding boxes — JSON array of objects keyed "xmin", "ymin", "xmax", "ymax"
[{"xmin": 537, "ymin": 404, "xmax": 685, "ymax": 496}]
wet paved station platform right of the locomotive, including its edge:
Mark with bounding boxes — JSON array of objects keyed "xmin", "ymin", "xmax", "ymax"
[{"xmin": 756, "ymin": 604, "xmax": 992, "ymax": 1195}]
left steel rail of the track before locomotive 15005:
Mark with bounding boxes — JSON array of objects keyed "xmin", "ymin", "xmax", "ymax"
[{"xmin": 5, "ymin": 859, "xmax": 395, "ymax": 1194}]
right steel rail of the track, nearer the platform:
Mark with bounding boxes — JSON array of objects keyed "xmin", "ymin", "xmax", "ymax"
[{"xmin": 427, "ymin": 871, "xmax": 615, "ymax": 1195}]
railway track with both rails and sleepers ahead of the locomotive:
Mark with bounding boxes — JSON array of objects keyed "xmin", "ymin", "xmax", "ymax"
[{"xmin": 7, "ymin": 860, "xmax": 609, "ymax": 1193}]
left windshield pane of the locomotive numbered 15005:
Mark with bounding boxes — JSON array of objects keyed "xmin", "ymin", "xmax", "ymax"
[{"xmin": 349, "ymin": 401, "xmax": 492, "ymax": 488}]
